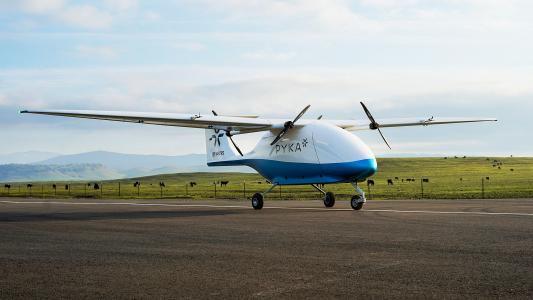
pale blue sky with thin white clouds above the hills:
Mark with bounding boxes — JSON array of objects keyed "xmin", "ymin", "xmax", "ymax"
[{"xmin": 0, "ymin": 0, "xmax": 533, "ymax": 156}]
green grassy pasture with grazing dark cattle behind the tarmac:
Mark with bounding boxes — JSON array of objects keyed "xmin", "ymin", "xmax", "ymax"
[{"xmin": 0, "ymin": 157, "xmax": 533, "ymax": 199}]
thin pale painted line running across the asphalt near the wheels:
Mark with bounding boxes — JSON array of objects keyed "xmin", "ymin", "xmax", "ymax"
[{"xmin": 0, "ymin": 200, "xmax": 533, "ymax": 217}]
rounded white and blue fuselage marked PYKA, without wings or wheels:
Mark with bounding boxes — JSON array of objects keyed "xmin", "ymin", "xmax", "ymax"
[{"xmin": 208, "ymin": 120, "xmax": 377, "ymax": 184}]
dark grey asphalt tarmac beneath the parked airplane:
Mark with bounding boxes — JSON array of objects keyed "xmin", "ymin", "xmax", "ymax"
[{"xmin": 0, "ymin": 198, "xmax": 533, "ymax": 299}]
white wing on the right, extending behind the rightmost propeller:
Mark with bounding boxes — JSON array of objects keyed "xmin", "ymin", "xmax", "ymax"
[{"xmin": 331, "ymin": 117, "xmax": 497, "ymax": 131}]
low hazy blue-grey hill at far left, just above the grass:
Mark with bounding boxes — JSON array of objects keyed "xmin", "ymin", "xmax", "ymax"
[{"xmin": 0, "ymin": 164, "xmax": 123, "ymax": 182}]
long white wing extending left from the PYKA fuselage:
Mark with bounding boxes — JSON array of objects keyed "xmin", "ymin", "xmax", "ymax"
[{"xmin": 20, "ymin": 110, "xmax": 274, "ymax": 133}]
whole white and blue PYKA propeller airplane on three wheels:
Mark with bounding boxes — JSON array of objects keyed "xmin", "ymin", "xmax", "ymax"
[{"xmin": 20, "ymin": 102, "xmax": 497, "ymax": 210}]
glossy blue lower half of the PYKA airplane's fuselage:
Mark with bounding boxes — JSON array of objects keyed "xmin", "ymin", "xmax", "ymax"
[{"xmin": 207, "ymin": 159, "xmax": 377, "ymax": 185}]
